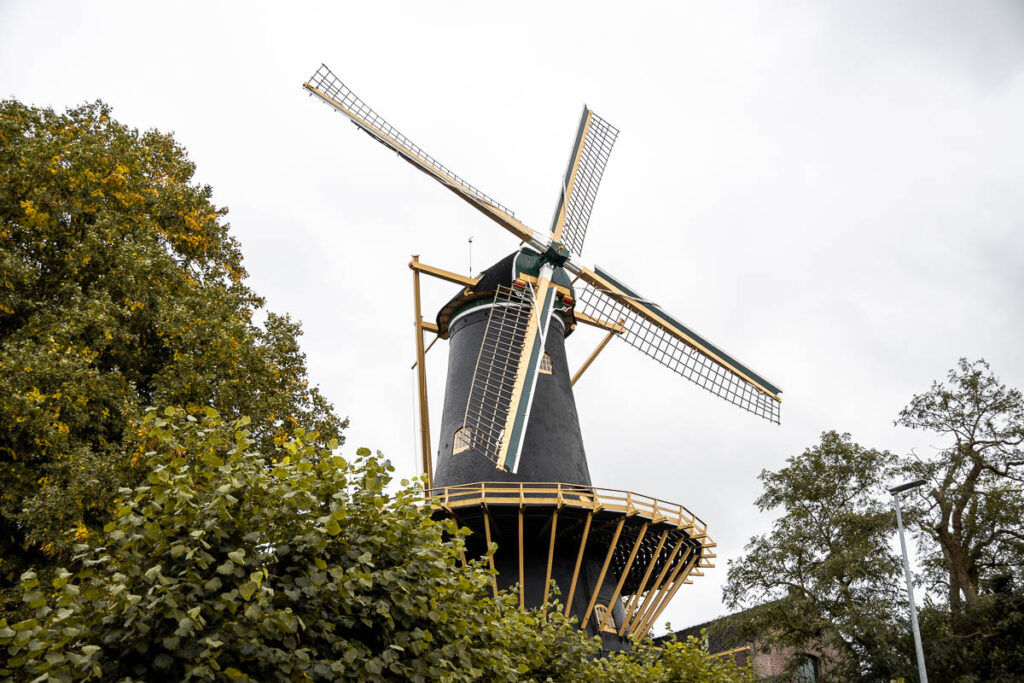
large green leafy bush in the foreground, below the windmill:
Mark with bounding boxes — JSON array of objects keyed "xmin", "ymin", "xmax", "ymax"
[{"xmin": 0, "ymin": 409, "xmax": 753, "ymax": 683}]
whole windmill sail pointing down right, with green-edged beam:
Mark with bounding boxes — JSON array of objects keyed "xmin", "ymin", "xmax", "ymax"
[{"xmin": 577, "ymin": 268, "xmax": 781, "ymax": 424}]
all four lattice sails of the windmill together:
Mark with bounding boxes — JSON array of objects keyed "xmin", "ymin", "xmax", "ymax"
[{"xmin": 303, "ymin": 65, "xmax": 781, "ymax": 428}]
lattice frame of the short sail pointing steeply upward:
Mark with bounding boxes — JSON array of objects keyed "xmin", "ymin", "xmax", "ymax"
[{"xmin": 561, "ymin": 110, "xmax": 618, "ymax": 256}]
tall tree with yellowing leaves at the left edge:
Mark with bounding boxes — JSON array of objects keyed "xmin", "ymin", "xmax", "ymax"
[{"xmin": 0, "ymin": 100, "xmax": 345, "ymax": 602}]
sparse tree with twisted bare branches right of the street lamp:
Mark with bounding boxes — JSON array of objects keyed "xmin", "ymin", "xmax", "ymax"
[{"xmin": 896, "ymin": 358, "xmax": 1024, "ymax": 625}]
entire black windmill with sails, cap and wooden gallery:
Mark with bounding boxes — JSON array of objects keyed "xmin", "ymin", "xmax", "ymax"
[{"xmin": 303, "ymin": 66, "xmax": 781, "ymax": 649}]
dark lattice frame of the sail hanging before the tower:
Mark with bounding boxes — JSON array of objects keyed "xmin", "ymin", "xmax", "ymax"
[{"xmin": 463, "ymin": 285, "xmax": 534, "ymax": 465}]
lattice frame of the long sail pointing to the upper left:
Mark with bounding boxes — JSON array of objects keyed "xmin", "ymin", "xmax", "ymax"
[{"xmin": 308, "ymin": 65, "xmax": 515, "ymax": 216}]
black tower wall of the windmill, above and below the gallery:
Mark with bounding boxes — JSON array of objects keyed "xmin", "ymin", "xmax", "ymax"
[{"xmin": 433, "ymin": 255, "xmax": 629, "ymax": 649}]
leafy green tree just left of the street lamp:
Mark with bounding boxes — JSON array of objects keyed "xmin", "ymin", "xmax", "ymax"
[{"xmin": 724, "ymin": 431, "xmax": 905, "ymax": 680}]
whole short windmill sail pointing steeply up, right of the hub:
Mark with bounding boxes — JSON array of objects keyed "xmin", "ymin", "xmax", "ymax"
[{"xmin": 551, "ymin": 106, "xmax": 618, "ymax": 256}]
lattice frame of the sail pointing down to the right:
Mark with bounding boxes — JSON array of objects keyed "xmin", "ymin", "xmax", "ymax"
[{"xmin": 575, "ymin": 283, "xmax": 781, "ymax": 424}]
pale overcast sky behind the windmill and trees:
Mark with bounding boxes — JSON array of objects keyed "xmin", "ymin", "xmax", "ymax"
[{"xmin": 0, "ymin": 0, "xmax": 1024, "ymax": 628}]
